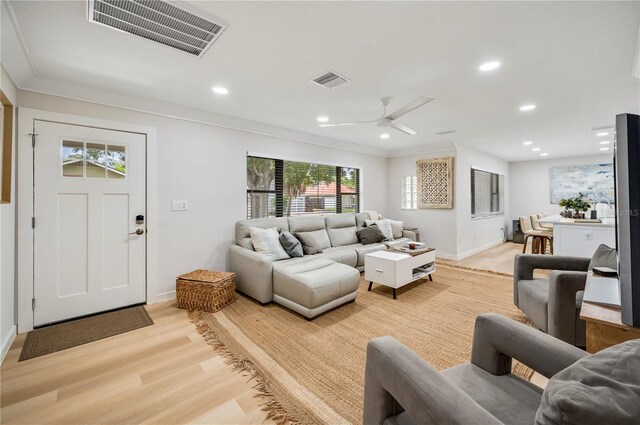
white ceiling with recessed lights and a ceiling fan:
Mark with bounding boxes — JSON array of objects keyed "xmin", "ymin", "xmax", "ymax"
[{"xmin": 3, "ymin": 1, "xmax": 640, "ymax": 161}]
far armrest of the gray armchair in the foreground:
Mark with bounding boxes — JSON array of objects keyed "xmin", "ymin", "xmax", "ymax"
[{"xmin": 471, "ymin": 313, "xmax": 587, "ymax": 378}]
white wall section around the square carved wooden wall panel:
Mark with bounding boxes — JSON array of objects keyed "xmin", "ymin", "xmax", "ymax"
[{"xmin": 388, "ymin": 150, "xmax": 460, "ymax": 259}]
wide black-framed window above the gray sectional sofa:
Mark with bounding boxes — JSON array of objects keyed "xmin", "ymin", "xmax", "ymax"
[{"xmin": 247, "ymin": 156, "xmax": 360, "ymax": 218}]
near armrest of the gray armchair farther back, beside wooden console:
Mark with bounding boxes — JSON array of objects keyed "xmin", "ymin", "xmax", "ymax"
[{"xmin": 547, "ymin": 271, "xmax": 587, "ymax": 345}]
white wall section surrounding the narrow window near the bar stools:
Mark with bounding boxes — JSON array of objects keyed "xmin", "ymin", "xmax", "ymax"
[{"xmin": 455, "ymin": 146, "xmax": 509, "ymax": 258}]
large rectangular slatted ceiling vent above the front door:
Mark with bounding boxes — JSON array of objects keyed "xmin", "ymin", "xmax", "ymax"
[{"xmin": 89, "ymin": 0, "xmax": 226, "ymax": 57}]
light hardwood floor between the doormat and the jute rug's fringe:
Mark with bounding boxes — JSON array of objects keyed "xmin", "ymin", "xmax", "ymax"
[{"xmin": 0, "ymin": 302, "xmax": 273, "ymax": 425}]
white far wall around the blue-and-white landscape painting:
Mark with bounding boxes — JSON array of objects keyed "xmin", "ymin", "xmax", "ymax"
[{"xmin": 509, "ymin": 153, "xmax": 613, "ymax": 220}]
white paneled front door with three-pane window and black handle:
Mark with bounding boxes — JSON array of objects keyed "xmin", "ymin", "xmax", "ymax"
[{"xmin": 33, "ymin": 120, "xmax": 146, "ymax": 326}]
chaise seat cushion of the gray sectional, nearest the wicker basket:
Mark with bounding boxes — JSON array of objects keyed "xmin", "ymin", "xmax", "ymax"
[{"xmin": 273, "ymin": 255, "xmax": 360, "ymax": 309}]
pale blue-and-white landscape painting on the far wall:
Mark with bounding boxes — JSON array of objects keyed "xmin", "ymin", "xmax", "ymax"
[{"xmin": 550, "ymin": 164, "xmax": 615, "ymax": 204}]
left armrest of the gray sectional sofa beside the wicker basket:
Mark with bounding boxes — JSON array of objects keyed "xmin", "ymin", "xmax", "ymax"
[{"xmin": 229, "ymin": 245, "xmax": 273, "ymax": 303}]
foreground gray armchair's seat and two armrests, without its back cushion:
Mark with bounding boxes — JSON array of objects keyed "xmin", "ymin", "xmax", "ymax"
[{"xmin": 363, "ymin": 313, "xmax": 587, "ymax": 425}]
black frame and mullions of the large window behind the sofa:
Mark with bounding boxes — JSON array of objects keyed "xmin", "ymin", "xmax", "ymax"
[{"xmin": 245, "ymin": 153, "xmax": 361, "ymax": 219}]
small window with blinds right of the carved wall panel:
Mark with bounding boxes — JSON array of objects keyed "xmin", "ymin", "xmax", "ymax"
[{"xmin": 471, "ymin": 168, "xmax": 504, "ymax": 218}]
